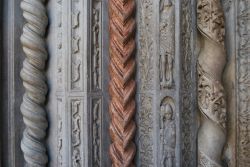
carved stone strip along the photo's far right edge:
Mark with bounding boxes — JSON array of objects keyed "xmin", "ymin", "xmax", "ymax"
[{"xmin": 236, "ymin": 0, "xmax": 250, "ymax": 167}]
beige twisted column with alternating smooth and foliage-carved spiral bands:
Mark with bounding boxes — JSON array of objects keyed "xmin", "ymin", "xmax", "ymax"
[{"xmin": 197, "ymin": 0, "xmax": 226, "ymax": 167}]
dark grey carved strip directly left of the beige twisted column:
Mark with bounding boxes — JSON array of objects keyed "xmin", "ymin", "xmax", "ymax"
[{"xmin": 180, "ymin": 0, "xmax": 197, "ymax": 167}]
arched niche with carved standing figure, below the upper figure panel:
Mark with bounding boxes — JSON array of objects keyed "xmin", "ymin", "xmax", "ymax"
[{"xmin": 159, "ymin": 97, "xmax": 176, "ymax": 167}]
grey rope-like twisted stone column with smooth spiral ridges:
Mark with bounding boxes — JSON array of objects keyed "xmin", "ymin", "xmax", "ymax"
[{"xmin": 20, "ymin": 0, "xmax": 48, "ymax": 167}]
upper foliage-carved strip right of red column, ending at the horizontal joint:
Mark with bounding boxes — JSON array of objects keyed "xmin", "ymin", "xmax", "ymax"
[{"xmin": 137, "ymin": 0, "xmax": 154, "ymax": 91}]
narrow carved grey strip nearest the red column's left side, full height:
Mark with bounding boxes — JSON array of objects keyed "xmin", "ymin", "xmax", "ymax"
[{"xmin": 88, "ymin": 0, "xmax": 103, "ymax": 167}]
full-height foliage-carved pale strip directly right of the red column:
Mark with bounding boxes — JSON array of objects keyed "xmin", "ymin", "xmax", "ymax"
[{"xmin": 136, "ymin": 0, "xmax": 156, "ymax": 167}]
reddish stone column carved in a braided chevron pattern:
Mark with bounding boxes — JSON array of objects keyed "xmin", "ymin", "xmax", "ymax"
[{"xmin": 109, "ymin": 0, "xmax": 136, "ymax": 167}]
